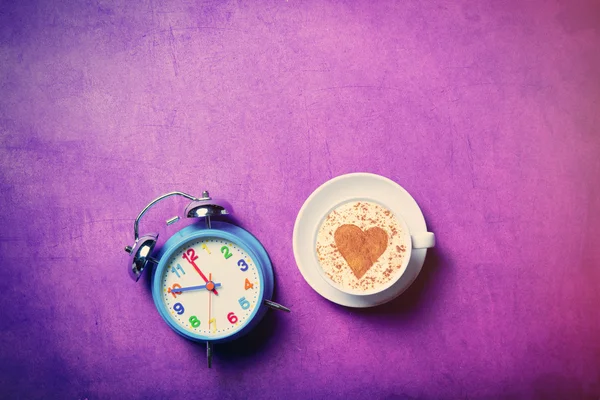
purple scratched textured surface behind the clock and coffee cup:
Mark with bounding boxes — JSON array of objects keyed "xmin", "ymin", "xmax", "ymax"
[{"xmin": 0, "ymin": 0, "xmax": 600, "ymax": 399}]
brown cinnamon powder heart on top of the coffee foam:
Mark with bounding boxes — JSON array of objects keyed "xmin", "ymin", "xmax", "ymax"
[{"xmin": 333, "ymin": 224, "xmax": 388, "ymax": 279}]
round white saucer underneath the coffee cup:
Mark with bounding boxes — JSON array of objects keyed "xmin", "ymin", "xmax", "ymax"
[{"xmin": 293, "ymin": 173, "xmax": 427, "ymax": 307}]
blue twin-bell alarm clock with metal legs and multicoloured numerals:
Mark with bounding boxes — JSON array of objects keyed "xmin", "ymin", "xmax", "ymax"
[{"xmin": 125, "ymin": 191, "xmax": 290, "ymax": 368}]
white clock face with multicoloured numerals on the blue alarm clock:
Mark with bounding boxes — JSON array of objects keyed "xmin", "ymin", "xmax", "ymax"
[{"xmin": 156, "ymin": 236, "xmax": 263, "ymax": 340}]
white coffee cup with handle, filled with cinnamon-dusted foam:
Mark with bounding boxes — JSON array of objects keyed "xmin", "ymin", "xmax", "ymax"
[{"xmin": 315, "ymin": 198, "xmax": 435, "ymax": 296}]
